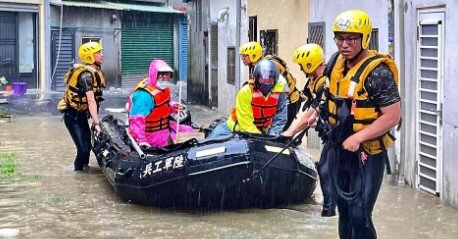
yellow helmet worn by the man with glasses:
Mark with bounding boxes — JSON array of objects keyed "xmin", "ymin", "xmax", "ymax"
[{"xmin": 332, "ymin": 10, "xmax": 372, "ymax": 49}]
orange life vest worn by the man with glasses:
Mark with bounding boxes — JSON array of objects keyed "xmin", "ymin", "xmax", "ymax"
[{"xmin": 326, "ymin": 51, "xmax": 399, "ymax": 154}]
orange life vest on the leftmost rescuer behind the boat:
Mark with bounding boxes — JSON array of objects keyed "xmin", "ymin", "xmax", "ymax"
[{"xmin": 64, "ymin": 64, "xmax": 105, "ymax": 111}]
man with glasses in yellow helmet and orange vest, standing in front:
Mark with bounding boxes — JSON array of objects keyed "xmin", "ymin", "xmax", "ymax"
[{"xmin": 282, "ymin": 10, "xmax": 401, "ymax": 239}]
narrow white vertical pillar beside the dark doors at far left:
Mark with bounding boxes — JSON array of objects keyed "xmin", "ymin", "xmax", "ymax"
[{"xmin": 38, "ymin": 0, "xmax": 51, "ymax": 93}]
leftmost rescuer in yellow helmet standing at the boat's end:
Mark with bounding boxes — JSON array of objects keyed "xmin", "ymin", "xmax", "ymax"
[{"xmin": 63, "ymin": 42, "xmax": 105, "ymax": 171}]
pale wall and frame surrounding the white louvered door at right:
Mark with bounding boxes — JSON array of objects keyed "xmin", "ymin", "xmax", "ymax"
[{"xmin": 398, "ymin": 0, "xmax": 458, "ymax": 207}]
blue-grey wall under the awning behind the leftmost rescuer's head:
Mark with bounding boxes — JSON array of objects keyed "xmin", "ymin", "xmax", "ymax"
[{"xmin": 51, "ymin": 7, "xmax": 121, "ymax": 87}]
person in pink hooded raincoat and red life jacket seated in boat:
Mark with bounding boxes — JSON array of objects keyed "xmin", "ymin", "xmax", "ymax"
[{"xmin": 127, "ymin": 60, "xmax": 193, "ymax": 147}]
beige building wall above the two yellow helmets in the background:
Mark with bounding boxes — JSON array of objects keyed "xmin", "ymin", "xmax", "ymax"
[{"xmin": 246, "ymin": 0, "xmax": 310, "ymax": 89}]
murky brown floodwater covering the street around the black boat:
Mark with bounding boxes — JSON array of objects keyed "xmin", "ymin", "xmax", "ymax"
[{"xmin": 0, "ymin": 115, "xmax": 458, "ymax": 238}]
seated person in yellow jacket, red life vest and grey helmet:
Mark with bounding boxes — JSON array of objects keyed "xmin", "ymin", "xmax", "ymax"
[{"xmin": 207, "ymin": 60, "xmax": 288, "ymax": 139}]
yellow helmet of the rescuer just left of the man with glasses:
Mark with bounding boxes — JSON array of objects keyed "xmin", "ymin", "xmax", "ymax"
[{"xmin": 293, "ymin": 43, "xmax": 324, "ymax": 74}]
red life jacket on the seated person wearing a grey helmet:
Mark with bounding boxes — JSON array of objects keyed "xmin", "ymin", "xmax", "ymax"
[{"xmin": 251, "ymin": 90, "xmax": 280, "ymax": 133}]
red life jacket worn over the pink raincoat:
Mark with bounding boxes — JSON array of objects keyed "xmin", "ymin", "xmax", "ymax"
[{"xmin": 143, "ymin": 86, "xmax": 171, "ymax": 133}]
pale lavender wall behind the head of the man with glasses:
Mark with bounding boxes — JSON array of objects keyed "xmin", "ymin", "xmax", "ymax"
[{"xmin": 310, "ymin": 0, "xmax": 389, "ymax": 58}]
